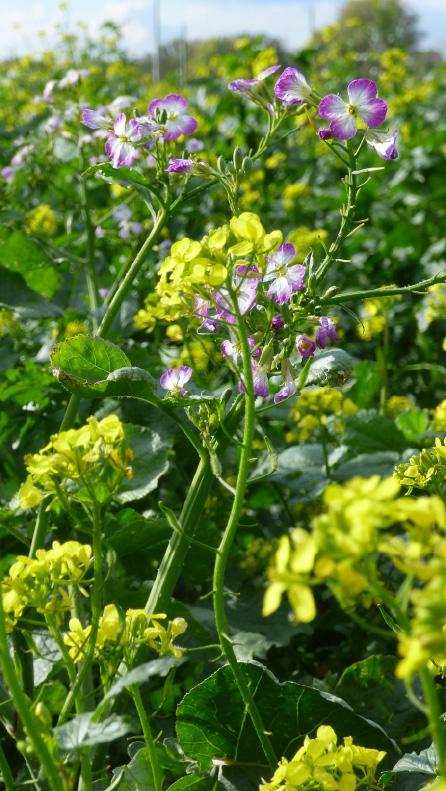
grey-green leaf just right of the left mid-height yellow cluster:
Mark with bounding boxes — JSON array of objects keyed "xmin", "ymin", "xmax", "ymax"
[{"xmin": 116, "ymin": 425, "xmax": 170, "ymax": 503}]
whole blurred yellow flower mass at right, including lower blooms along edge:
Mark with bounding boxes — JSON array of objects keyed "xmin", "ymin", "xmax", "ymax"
[{"xmin": 263, "ymin": 475, "xmax": 446, "ymax": 678}]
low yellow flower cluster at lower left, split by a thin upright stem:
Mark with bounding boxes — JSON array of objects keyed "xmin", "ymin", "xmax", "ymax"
[{"xmin": 64, "ymin": 604, "xmax": 187, "ymax": 662}]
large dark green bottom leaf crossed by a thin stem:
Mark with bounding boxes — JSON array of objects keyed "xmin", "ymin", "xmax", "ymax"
[{"xmin": 177, "ymin": 663, "xmax": 397, "ymax": 771}]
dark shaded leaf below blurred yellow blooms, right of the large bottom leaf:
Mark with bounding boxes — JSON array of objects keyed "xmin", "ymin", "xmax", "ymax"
[{"xmin": 335, "ymin": 656, "xmax": 424, "ymax": 739}]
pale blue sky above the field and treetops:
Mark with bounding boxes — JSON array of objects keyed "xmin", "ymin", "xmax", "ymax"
[{"xmin": 0, "ymin": 0, "xmax": 446, "ymax": 57}]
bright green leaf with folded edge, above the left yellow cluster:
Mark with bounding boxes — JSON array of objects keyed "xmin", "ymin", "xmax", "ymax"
[{"xmin": 51, "ymin": 335, "xmax": 159, "ymax": 403}]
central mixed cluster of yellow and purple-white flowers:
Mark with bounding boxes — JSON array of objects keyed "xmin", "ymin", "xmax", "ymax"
[{"xmin": 135, "ymin": 212, "xmax": 337, "ymax": 403}]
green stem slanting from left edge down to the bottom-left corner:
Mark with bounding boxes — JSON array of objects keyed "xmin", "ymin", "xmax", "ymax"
[{"xmin": 0, "ymin": 596, "xmax": 63, "ymax": 791}]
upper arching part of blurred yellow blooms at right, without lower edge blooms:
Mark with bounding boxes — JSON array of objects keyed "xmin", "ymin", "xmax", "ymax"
[{"xmin": 263, "ymin": 475, "xmax": 446, "ymax": 622}]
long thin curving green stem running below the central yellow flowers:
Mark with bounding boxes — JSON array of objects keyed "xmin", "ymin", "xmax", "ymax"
[{"xmin": 213, "ymin": 300, "xmax": 277, "ymax": 768}]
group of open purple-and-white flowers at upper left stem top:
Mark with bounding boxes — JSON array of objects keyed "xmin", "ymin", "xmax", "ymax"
[{"xmin": 82, "ymin": 93, "xmax": 197, "ymax": 168}]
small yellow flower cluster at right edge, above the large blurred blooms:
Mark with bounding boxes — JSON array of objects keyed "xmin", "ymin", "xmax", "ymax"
[{"xmin": 394, "ymin": 440, "xmax": 446, "ymax": 494}]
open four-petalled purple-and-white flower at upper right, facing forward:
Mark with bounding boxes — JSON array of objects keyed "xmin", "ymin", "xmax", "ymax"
[{"xmin": 319, "ymin": 79, "xmax": 387, "ymax": 140}]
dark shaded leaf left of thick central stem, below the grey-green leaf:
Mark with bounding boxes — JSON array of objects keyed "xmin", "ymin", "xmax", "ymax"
[{"xmin": 106, "ymin": 508, "xmax": 172, "ymax": 558}]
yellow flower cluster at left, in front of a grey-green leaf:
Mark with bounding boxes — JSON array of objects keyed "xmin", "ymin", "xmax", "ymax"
[{"xmin": 19, "ymin": 415, "xmax": 133, "ymax": 508}]
